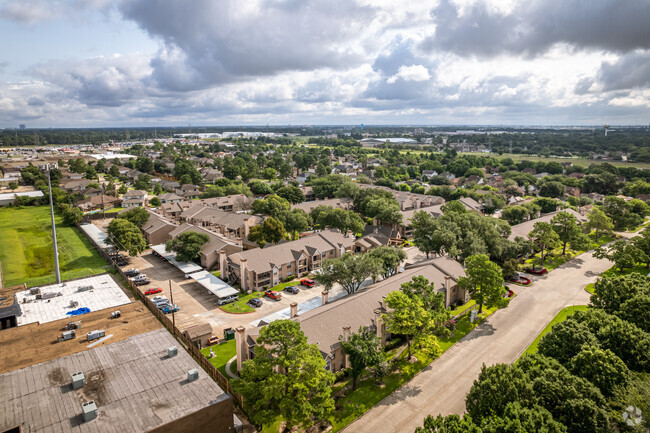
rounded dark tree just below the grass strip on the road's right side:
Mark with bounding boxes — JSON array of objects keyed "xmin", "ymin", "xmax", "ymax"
[{"xmin": 538, "ymin": 320, "xmax": 599, "ymax": 365}]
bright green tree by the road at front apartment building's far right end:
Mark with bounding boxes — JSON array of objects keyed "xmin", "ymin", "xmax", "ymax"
[{"xmin": 458, "ymin": 254, "xmax": 508, "ymax": 314}]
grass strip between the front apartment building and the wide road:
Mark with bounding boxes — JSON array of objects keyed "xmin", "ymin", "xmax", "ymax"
[{"xmin": 330, "ymin": 308, "xmax": 495, "ymax": 432}]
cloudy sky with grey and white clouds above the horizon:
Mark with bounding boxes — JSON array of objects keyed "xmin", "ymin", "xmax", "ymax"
[{"xmin": 0, "ymin": 0, "xmax": 650, "ymax": 128}]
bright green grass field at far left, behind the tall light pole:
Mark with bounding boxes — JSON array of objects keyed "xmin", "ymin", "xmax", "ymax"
[{"xmin": 0, "ymin": 206, "xmax": 108, "ymax": 287}]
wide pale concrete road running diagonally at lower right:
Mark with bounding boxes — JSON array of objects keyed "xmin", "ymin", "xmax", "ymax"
[{"xmin": 345, "ymin": 253, "xmax": 612, "ymax": 433}]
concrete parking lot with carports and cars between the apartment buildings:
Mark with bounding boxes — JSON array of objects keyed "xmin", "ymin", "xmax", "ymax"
[{"xmin": 122, "ymin": 251, "xmax": 332, "ymax": 337}]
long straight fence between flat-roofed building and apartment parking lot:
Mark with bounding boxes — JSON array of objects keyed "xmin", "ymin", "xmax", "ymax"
[{"xmin": 80, "ymin": 223, "xmax": 244, "ymax": 411}]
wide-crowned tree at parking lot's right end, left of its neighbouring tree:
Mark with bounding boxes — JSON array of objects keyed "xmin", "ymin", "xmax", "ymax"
[{"xmin": 314, "ymin": 253, "xmax": 382, "ymax": 295}]
